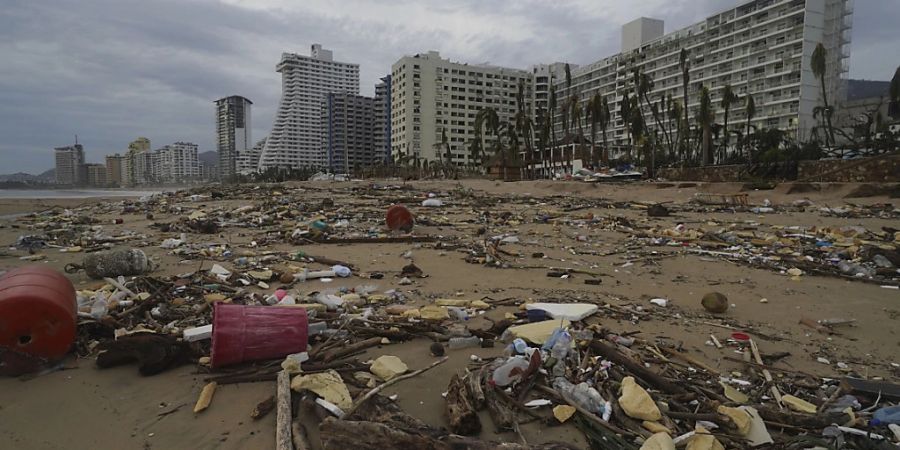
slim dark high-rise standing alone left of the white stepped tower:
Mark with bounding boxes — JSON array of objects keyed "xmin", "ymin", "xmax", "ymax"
[{"xmin": 216, "ymin": 95, "xmax": 253, "ymax": 180}]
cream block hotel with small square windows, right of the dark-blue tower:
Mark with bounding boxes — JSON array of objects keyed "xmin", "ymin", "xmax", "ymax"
[{"xmin": 390, "ymin": 51, "xmax": 532, "ymax": 166}]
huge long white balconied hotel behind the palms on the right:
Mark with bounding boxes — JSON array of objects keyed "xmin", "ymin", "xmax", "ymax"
[{"xmin": 555, "ymin": 0, "xmax": 853, "ymax": 162}]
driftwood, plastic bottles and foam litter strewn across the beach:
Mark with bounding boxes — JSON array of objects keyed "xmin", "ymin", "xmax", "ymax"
[{"xmin": 0, "ymin": 181, "xmax": 900, "ymax": 450}]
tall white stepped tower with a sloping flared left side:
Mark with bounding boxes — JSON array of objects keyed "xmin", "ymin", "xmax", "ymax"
[{"xmin": 259, "ymin": 44, "xmax": 359, "ymax": 170}]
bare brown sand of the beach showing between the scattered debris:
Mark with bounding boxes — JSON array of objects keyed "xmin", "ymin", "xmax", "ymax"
[{"xmin": 0, "ymin": 180, "xmax": 900, "ymax": 450}]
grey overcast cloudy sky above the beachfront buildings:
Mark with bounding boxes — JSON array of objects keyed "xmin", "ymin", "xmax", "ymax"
[{"xmin": 0, "ymin": 0, "xmax": 900, "ymax": 173}]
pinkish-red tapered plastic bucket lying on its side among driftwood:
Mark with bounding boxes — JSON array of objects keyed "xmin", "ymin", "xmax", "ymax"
[{"xmin": 210, "ymin": 303, "xmax": 309, "ymax": 367}]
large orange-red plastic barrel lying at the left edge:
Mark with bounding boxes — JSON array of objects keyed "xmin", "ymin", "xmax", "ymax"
[{"xmin": 0, "ymin": 265, "xmax": 78, "ymax": 366}]
